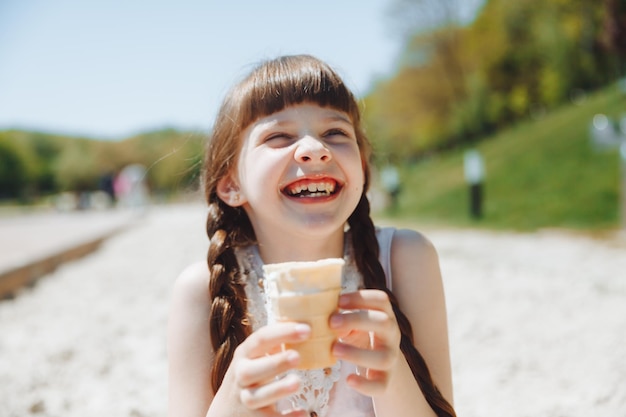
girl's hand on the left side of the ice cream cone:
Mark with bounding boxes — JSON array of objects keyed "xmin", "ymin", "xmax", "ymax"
[{"xmin": 218, "ymin": 323, "xmax": 311, "ymax": 417}]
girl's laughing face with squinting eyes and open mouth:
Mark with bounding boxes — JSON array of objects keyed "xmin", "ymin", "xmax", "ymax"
[{"xmin": 220, "ymin": 103, "xmax": 365, "ymax": 242}]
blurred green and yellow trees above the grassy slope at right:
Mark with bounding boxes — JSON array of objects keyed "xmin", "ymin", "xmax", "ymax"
[{"xmin": 366, "ymin": 0, "xmax": 626, "ymax": 161}]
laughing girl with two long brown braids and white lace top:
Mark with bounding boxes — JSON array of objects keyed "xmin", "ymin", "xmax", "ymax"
[{"xmin": 168, "ymin": 55, "xmax": 455, "ymax": 417}]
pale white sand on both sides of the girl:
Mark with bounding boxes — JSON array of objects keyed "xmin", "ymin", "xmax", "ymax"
[{"xmin": 0, "ymin": 205, "xmax": 626, "ymax": 417}]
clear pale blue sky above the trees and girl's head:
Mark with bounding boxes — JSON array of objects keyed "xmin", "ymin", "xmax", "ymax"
[{"xmin": 0, "ymin": 0, "xmax": 480, "ymax": 139}]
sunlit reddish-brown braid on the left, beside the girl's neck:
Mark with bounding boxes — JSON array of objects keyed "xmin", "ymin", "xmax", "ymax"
[{"xmin": 207, "ymin": 202, "xmax": 251, "ymax": 392}]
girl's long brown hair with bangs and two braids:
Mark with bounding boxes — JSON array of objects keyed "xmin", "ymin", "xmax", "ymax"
[{"xmin": 204, "ymin": 55, "xmax": 455, "ymax": 417}]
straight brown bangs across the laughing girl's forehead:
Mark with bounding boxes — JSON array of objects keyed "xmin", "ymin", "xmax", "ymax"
[{"xmin": 239, "ymin": 55, "xmax": 359, "ymax": 126}]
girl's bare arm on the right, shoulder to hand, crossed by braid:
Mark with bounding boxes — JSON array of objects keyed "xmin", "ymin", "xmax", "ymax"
[{"xmin": 331, "ymin": 230, "xmax": 452, "ymax": 417}]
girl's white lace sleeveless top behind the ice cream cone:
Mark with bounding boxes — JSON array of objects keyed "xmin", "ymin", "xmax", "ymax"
[{"xmin": 235, "ymin": 228, "xmax": 395, "ymax": 417}]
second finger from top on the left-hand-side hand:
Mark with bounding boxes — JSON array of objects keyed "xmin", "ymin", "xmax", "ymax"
[{"xmin": 235, "ymin": 350, "xmax": 300, "ymax": 388}]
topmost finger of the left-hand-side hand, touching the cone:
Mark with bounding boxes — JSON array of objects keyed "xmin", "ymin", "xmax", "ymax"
[{"xmin": 240, "ymin": 322, "xmax": 311, "ymax": 359}]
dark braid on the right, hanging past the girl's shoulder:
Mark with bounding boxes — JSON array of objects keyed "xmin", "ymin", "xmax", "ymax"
[{"xmin": 348, "ymin": 193, "xmax": 456, "ymax": 417}]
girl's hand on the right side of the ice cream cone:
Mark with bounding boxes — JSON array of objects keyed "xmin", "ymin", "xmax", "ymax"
[{"xmin": 330, "ymin": 289, "xmax": 401, "ymax": 396}]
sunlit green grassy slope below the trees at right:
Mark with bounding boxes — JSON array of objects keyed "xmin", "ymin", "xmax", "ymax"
[{"xmin": 383, "ymin": 86, "xmax": 626, "ymax": 231}]
